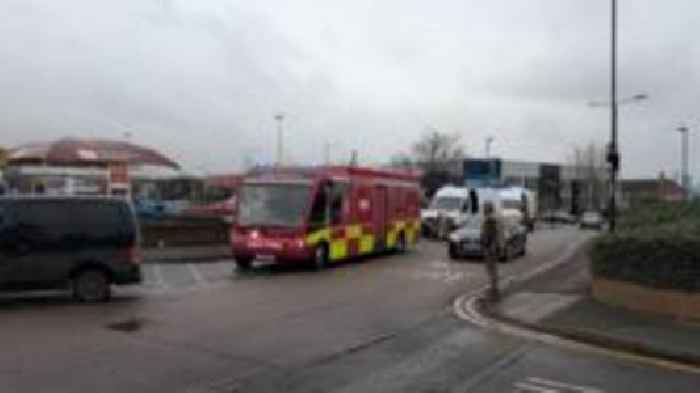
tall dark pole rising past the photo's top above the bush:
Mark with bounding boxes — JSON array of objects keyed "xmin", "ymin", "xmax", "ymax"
[{"xmin": 607, "ymin": 0, "xmax": 620, "ymax": 233}]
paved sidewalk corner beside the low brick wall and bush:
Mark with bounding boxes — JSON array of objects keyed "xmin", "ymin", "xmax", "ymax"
[{"xmin": 493, "ymin": 236, "xmax": 700, "ymax": 366}]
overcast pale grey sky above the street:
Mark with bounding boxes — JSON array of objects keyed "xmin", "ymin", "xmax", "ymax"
[{"xmin": 0, "ymin": 0, "xmax": 700, "ymax": 176}]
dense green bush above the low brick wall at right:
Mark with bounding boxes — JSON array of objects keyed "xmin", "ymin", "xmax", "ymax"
[{"xmin": 591, "ymin": 230, "xmax": 700, "ymax": 292}]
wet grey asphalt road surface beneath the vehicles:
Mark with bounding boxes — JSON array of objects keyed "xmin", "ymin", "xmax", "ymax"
[{"xmin": 0, "ymin": 228, "xmax": 700, "ymax": 393}]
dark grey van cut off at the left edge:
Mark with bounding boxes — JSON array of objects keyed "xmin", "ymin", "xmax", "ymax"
[{"xmin": 0, "ymin": 197, "xmax": 141, "ymax": 302}]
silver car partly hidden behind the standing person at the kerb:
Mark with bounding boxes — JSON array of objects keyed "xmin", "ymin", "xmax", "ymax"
[{"xmin": 448, "ymin": 217, "xmax": 528, "ymax": 262}]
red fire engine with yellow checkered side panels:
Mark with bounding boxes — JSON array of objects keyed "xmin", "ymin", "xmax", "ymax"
[{"xmin": 231, "ymin": 167, "xmax": 420, "ymax": 269}]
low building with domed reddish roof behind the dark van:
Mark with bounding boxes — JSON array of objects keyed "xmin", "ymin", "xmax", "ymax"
[{"xmin": 4, "ymin": 138, "xmax": 203, "ymax": 211}]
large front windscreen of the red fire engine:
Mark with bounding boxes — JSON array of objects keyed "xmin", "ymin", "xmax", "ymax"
[{"xmin": 238, "ymin": 184, "xmax": 311, "ymax": 227}]
